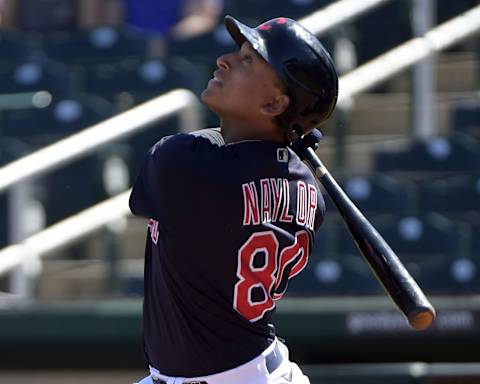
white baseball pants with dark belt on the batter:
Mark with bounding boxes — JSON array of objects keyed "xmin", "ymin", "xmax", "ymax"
[{"xmin": 133, "ymin": 340, "xmax": 310, "ymax": 384}]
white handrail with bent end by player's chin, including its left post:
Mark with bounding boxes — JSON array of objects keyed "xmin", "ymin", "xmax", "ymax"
[{"xmin": 0, "ymin": 90, "xmax": 201, "ymax": 296}]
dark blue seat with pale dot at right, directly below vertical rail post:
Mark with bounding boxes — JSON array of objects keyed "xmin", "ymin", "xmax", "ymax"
[{"xmin": 375, "ymin": 134, "xmax": 480, "ymax": 172}]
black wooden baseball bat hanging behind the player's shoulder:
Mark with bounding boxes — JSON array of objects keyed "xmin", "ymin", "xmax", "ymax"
[{"xmin": 297, "ymin": 131, "xmax": 436, "ymax": 330}]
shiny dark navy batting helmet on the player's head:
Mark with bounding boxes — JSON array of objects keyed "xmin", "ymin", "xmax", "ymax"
[{"xmin": 225, "ymin": 16, "xmax": 338, "ymax": 134}]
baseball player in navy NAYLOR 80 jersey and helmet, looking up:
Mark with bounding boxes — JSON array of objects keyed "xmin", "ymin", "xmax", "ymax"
[{"xmin": 130, "ymin": 16, "xmax": 338, "ymax": 384}]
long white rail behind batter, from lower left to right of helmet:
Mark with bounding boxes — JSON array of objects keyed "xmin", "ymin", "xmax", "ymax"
[{"xmin": 0, "ymin": 0, "xmax": 480, "ymax": 296}]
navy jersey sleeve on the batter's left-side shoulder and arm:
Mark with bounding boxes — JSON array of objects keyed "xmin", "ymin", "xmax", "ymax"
[{"xmin": 129, "ymin": 130, "xmax": 223, "ymax": 223}]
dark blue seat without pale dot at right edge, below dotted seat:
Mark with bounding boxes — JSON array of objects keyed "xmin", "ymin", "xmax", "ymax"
[{"xmin": 419, "ymin": 173, "xmax": 480, "ymax": 213}]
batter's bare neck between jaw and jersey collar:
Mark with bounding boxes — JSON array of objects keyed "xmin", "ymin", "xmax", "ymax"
[{"xmin": 220, "ymin": 118, "xmax": 284, "ymax": 144}]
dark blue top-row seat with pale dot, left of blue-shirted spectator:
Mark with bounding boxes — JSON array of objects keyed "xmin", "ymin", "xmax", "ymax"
[{"xmin": 43, "ymin": 26, "xmax": 148, "ymax": 64}]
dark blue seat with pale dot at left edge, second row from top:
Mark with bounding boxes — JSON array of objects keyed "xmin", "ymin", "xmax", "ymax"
[{"xmin": 0, "ymin": 60, "xmax": 79, "ymax": 96}]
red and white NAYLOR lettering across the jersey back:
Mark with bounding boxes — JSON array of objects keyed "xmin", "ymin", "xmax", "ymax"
[{"xmin": 242, "ymin": 178, "xmax": 318, "ymax": 230}]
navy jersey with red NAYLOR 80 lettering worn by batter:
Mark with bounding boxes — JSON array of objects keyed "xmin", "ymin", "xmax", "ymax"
[{"xmin": 130, "ymin": 130, "xmax": 325, "ymax": 377}]
